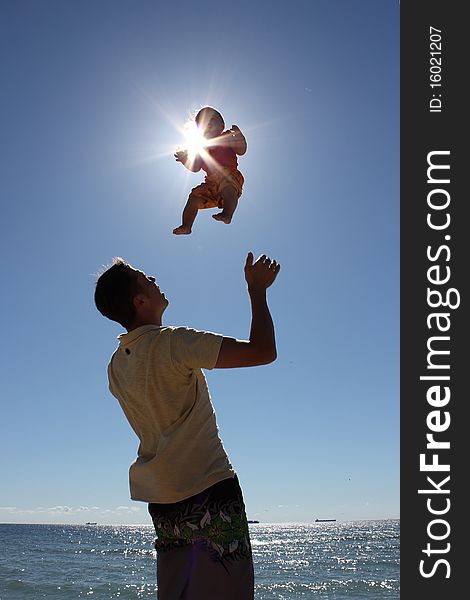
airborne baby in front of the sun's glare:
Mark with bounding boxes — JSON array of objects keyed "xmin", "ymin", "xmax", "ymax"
[{"xmin": 173, "ymin": 106, "xmax": 246, "ymax": 235}]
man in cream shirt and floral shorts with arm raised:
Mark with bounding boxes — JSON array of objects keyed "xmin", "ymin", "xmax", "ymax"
[{"xmin": 95, "ymin": 252, "xmax": 280, "ymax": 600}]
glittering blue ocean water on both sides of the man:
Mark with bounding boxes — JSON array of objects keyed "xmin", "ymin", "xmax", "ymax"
[{"xmin": 0, "ymin": 520, "xmax": 400, "ymax": 600}]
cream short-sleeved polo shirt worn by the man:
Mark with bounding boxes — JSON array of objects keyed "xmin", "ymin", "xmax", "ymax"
[{"xmin": 108, "ymin": 325, "xmax": 235, "ymax": 503}]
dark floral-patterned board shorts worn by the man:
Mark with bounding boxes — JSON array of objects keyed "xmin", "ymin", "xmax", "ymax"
[{"xmin": 148, "ymin": 477, "xmax": 254, "ymax": 600}]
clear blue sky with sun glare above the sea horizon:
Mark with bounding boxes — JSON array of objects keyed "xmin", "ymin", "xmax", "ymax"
[{"xmin": 0, "ymin": 0, "xmax": 399, "ymax": 523}]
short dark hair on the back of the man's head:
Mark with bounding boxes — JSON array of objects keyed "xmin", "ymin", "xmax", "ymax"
[{"xmin": 95, "ymin": 257, "xmax": 142, "ymax": 329}]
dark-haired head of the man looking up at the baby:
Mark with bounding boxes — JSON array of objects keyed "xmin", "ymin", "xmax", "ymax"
[{"xmin": 95, "ymin": 257, "xmax": 168, "ymax": 331}]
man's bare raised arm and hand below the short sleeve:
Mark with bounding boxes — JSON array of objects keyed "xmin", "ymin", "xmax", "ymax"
[{"xmin": 215, "ymin": 252, "xmax": 281, "ymax": 369}]
